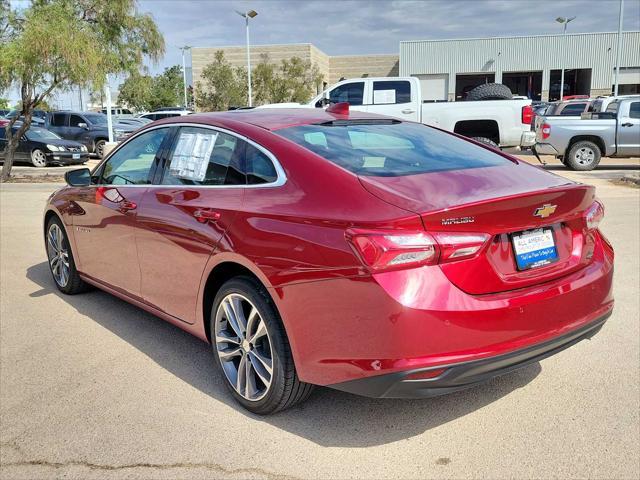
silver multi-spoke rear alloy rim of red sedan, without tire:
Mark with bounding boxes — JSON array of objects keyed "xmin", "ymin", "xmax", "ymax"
[{"xmin": 215, "ymin": 293, "xmax": 273, "ymax": 401}]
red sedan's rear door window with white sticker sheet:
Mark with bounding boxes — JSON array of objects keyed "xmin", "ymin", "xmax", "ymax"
[{"xmin": 162, "ymin": 127, "xmax": 246, "ymax": 185}]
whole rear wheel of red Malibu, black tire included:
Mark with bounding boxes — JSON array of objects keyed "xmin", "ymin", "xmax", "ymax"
[{"xmin": 209, "ymin": 276, "xmax": 314, "ymax": 415}]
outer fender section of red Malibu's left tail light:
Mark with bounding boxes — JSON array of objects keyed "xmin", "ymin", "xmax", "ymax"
[{"xmin": 346, "ymin": 229, "xmax": 438, "ymax": 272}]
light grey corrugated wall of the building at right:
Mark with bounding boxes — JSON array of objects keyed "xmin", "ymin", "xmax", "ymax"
[{"xmin": 400, "ymin": 32, "xmax": 640, "ymax": 100}]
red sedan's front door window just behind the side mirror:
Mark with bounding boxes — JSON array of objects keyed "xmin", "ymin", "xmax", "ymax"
[{"xmin": 100, "ymin": 128, "xmax": 169, "ymax": 185}]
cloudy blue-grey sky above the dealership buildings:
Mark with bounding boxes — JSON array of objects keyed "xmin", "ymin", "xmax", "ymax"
[{"xmin": 6, "ymin": 0, "xmax": 640, "ymax": 108}]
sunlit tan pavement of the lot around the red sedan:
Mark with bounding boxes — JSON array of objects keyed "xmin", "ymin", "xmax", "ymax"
[{"xmin": 0, "ymin": 168, "xmax": 640, "ymax": 479}]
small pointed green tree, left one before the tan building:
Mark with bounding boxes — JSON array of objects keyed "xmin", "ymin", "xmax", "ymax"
[{"xmin": 195, "ymin": 50, "xmax": 247, "ymax": 111}]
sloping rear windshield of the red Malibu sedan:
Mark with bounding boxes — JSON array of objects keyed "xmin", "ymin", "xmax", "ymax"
[{"xmin": 274, "ymin": 121, "xmax": 509, "ymax": 177}]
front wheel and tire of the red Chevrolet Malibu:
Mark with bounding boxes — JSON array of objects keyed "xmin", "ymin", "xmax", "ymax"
[{"xmin": 45, "ymin": 216, "xmax": 90, "ymax": 295}]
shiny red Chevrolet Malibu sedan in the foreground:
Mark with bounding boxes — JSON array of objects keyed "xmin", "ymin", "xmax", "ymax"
[{"xmin": 44, "ymin": 104, "xmax": 613, "ymax": 414}]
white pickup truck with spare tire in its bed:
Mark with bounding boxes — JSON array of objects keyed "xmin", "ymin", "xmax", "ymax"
[{"xmin": 264, "ymin": 77, "xmax": 535, "ymax": 147}]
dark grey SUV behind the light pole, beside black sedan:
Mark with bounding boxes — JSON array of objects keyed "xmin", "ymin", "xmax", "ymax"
[{"xmin": 46, "ymin": 111, "xmax": 136, "ymax": 158}]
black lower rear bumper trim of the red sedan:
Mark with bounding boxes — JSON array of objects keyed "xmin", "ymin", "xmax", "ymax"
[{"xmin": 328, "ymin": 311, "xmax": 611, "ymax": 398}]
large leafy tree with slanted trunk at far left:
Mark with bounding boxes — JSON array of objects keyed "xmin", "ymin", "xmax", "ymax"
[{"xmin": 0, "ymin": 0, "xmax": 164, "ymax": 180}]
